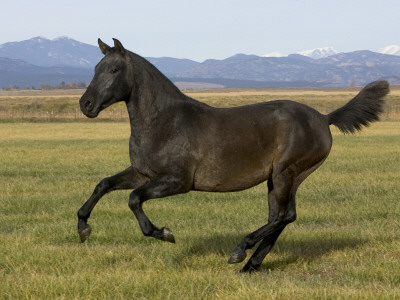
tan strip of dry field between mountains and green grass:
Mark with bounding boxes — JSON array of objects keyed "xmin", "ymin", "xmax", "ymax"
[{"xmin": 0, "ymin": 86, "xmax": 400, "ymax": 122}]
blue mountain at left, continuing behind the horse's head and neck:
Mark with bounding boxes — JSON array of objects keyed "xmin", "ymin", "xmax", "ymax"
[{"xmin": 0, "ymin": 37, "xmax": 199, "ymax": 88}]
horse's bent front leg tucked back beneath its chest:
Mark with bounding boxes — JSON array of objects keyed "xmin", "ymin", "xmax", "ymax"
[{"xmin": 129, "ymin": 175, "xmax": 191, "ymax": 243}]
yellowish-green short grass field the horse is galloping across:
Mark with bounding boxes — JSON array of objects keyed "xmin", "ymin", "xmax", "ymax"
[{"xmin": 0, "ymin": 91, "xmax": 400, "ymax": 299}]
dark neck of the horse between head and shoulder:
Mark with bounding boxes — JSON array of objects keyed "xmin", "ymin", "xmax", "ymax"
[{"xmin": 126, "ymin": 53, "xmax": 187, "ymax": 132}]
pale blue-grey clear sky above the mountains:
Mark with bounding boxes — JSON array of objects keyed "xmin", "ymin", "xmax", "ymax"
[{"xmin": 0, "ymin": 0, "xmax": 400, "ymax": 62}]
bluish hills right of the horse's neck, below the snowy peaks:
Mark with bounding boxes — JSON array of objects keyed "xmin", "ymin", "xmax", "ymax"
[{"xmin": 177, "ymin": 51, "xmax": 400, "ymax": 87}]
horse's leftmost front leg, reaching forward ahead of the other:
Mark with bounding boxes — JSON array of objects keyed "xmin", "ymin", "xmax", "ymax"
[{"xmin": 78, "ymin": 167, "xmax": 148, "ymax": 243}]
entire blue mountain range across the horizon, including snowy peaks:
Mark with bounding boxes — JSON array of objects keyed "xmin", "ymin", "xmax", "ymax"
[{"xmin": 0, "ymin": 37, "xmax": 400, "ymax": 88}]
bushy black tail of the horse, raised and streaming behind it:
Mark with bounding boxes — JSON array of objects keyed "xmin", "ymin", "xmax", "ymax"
[{"xmin": 327, "ymin": 80, "xmax": 389, "ymax": 133}]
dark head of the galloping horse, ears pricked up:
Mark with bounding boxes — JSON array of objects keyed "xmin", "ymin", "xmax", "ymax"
[{"xmin": 79, "ymin": 39, "xmax": 132, "ymax": 118}]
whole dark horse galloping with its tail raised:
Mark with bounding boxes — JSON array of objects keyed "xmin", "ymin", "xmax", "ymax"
[{"xmin": 78, "ymin": 39, "xmax": 389, "ymax": 272}]
